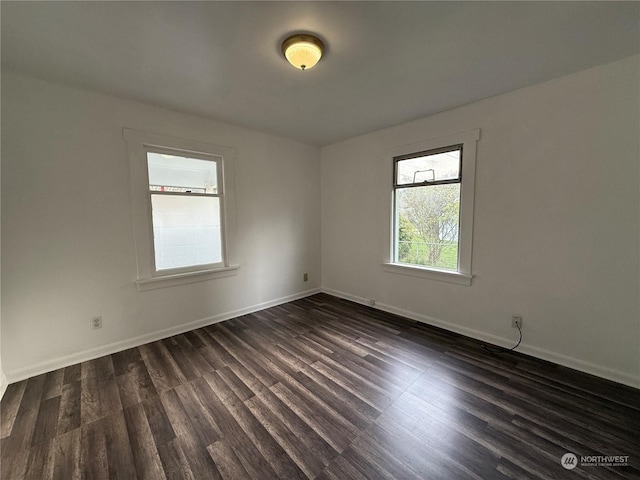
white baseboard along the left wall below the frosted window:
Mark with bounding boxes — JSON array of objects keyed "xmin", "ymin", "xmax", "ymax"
[{"xmin": 2, "ymin": 288, "xmax": 321, "ymax": 384}]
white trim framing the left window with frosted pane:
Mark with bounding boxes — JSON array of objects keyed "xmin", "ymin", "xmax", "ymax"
[{"xmin": 123, "ymin": 128, "xmax": 240, "ymax": 290}]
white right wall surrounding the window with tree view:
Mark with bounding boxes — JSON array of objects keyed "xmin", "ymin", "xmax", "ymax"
[{"xmin": 321, "ymin": 56, "xmax": 640, "ymax": 386}]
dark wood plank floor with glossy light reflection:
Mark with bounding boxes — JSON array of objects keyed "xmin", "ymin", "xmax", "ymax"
[{"xmin": 1, "ymin": 294, "xmax": 640, "ymax": 480}]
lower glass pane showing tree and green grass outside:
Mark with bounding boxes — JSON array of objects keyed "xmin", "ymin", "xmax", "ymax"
[{"xmin": 395, "ymin": 183, "xmax": 460, "ymax": 271}]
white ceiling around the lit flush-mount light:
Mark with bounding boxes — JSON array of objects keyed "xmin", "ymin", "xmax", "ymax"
[{"xmin": 0, "ymin": 1, "xmax": 640, "ymax": 145}]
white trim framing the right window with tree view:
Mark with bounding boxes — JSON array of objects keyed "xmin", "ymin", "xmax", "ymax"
[{"xmin": 382, "ymin": 129, "xmax": 480, "ymax": 285}]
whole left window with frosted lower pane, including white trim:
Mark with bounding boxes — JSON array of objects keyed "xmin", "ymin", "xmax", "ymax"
[{"xmin": 124, "ymin": 129, "xmax": 238, "ymax": 289}]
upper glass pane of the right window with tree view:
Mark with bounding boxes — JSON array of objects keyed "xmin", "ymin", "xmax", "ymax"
[{"xmin": 396, "ymin": 149, "xmax": 460, "ymax": 185}]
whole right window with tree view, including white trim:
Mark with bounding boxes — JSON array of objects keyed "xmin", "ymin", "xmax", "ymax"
[{"xmin": 385, "ymin": 130, "xmax": 479, "ymax": 285}]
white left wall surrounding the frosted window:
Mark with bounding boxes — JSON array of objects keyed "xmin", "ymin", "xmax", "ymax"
[{"xmin": 2, "ymin": 73, "xmax": 320, "ymax": 381}]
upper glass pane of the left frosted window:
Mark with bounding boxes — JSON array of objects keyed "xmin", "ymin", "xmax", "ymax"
[{"xmin": 147, "ymin": 152, "xmax": 219, "ymax": 193}]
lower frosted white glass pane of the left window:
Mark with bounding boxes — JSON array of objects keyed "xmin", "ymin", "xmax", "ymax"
[{"xmin": 151, "ymin": 195, "xmax": 222, "ymax": 270}]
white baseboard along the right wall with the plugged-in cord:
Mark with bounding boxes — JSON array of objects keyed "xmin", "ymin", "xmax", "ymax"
[{"xmin": 322, "ymin": 287, "xmax": 640, "ymax": 388}]
